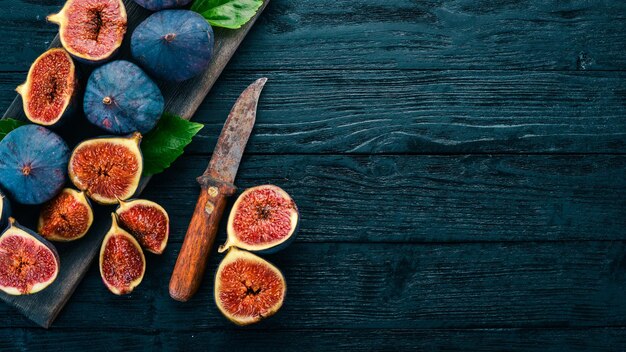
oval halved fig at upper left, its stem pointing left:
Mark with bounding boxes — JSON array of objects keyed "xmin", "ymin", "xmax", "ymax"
[{"xmin": 16, "ymin": 48, "xmax": 78, "ymax": 126}]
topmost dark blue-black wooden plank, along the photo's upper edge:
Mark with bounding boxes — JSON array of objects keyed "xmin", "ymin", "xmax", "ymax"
[{"xmin": 0, "ymin": 0, "xmax": 626, "ymax": 71}]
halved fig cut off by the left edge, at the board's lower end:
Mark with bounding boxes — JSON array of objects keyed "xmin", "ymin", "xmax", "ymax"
[{"xmin": 0, "ymin": 218, "xmax": 59, "ymax": 295}]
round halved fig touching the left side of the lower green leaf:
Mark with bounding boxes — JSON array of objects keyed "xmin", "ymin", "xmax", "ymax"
[{"xmin": 68, "ymin": 132, "xmax": 143, "ymax": 205}]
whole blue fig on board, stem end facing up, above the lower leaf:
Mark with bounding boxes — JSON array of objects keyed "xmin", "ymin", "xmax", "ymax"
[{"xmin": 83, "ymin": 60, "xmax": 165, "ymax": 134}]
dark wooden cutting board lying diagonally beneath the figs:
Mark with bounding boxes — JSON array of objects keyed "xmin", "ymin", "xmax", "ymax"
[{"xmin": 0, "ymin": 0, "xmax": 269, "ymax": 328}]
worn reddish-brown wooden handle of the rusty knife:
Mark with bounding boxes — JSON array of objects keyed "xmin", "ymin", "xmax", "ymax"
[{"xmin": 170, "ymin": 176, "xmax": 236, "ymax": 302}]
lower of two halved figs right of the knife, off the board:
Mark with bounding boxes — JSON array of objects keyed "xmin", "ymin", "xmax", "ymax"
[{"xmin": 214, "ymin": 247, "xmax": 287, "ymax": 325}]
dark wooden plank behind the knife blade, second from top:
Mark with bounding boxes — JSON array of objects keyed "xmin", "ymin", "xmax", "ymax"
[{"xmin": 0, "ymin": 70, "xmax": 626, "ymax": 154}]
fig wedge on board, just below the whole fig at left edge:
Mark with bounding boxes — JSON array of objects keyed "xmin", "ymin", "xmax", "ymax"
[{"xmin": 37, "ymin": 188, "xmax": 93, "ymax": 242}]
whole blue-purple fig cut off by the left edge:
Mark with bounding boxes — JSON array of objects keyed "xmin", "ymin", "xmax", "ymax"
[{"xmin": 0, "ymin": 125, "xmax": 70, "ymax": 204}]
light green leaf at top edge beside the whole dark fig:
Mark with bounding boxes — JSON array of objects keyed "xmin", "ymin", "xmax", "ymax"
[{"xmin": 191, "ymin": 0, "xmax": 263, "ymax": 29}]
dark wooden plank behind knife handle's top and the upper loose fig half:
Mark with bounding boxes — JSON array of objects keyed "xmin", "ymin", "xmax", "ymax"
[{"xmin": 140, "ymin": 155, "xmax": 626, "ymax": 242}]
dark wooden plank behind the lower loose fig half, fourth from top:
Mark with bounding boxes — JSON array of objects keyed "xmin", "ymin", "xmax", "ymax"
[{"xmin": 0, "ymin": 241, "xmax": 626, "ymax": 333}]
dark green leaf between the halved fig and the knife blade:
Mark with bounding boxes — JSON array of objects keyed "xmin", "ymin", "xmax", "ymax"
[{"xmin": 141, "ymin": 112, "xmax": 204, "ymax": 176}]
